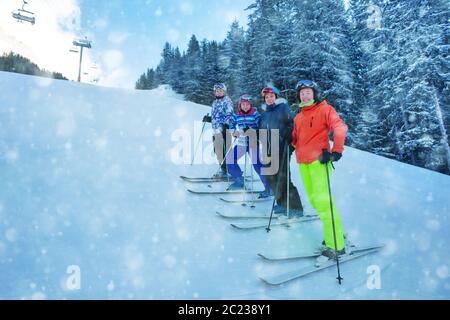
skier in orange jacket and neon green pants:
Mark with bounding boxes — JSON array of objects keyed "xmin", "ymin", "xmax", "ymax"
[{"xmin": 292, "ymin": 80, "xmax": 348, "ymax": 259}]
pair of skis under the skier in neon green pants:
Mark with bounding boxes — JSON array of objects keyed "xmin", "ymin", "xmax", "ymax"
[{"xmin": 258, "ymin": 245, "xmax": 384, "ymax": 286}]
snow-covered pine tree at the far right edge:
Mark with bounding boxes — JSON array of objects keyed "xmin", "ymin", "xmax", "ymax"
[{"xmin": 396, "ymin": 0, "xmax": 448, "ymax": 172}]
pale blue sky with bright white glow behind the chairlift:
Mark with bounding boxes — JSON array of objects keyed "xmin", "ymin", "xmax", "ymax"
[{"xmin": 0, "ymin": 0, "xmax": 253, "ymax": 88}]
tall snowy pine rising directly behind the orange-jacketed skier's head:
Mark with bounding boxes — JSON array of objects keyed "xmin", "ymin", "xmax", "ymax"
[{"xmin": 292, "ymin": 0, "xmax": 358, "ymax": 143}]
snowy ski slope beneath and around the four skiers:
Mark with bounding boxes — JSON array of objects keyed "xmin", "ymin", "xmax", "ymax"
[{"xmin": 0, "ymin": 72, "xmax": 450, "ymax": 299}]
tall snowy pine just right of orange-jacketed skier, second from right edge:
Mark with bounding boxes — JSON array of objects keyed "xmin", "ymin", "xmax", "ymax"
[{"xmin": 349, "ymin": 0, "xmax": 399, "ymax": 159}]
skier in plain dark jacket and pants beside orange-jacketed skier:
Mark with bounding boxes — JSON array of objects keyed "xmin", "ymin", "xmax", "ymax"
[{"xmin": 259, "ymin": 87, "xmax": 303, "ymax": 217}]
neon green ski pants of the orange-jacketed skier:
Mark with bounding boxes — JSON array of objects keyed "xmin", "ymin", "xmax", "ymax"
[{"xmin": 300, "ymin": 160, "xmax": 345, "ymax": 250}]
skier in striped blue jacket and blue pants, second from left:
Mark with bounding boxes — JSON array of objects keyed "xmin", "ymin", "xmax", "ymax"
[{"xmin": 226, "ymin": 94, "xmax": 271, "ymax": 199}]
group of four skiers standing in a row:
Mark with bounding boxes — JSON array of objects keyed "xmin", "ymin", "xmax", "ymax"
[{"xmin": 203, "ymin": 80, "xmax": 348, "ymax": 259}]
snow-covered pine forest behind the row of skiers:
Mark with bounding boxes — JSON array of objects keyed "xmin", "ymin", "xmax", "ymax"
[{"xmin": 136, "ymin": 0, "xmax": 450, "ymax": 174}]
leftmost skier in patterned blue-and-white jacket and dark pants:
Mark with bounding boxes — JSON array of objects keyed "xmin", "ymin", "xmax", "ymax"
[{"xmin": 211, "ymin": 83, "xmax": 234, "ymax": 178}]
